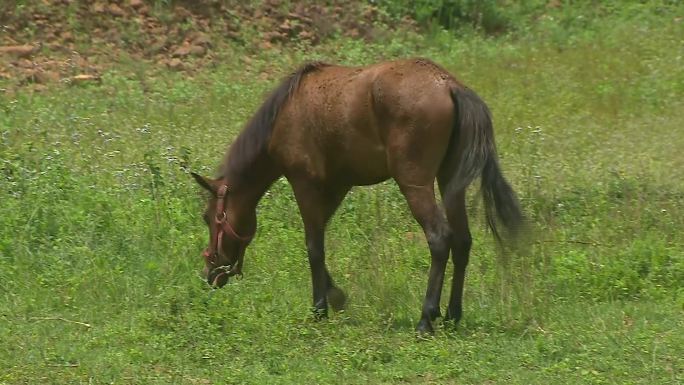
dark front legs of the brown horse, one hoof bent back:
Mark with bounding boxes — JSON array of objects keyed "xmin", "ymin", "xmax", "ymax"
[{"xmin": 291, "ymin": 180, "xmax": 349, "ymax": 317}]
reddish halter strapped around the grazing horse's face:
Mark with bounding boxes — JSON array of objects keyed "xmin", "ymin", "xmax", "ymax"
[{"xmin": 202, "ymin": 184, "xmax": 254, "ymax": 282}]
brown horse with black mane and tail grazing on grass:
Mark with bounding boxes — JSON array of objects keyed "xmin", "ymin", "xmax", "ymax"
[{"xmin": 193, "ymin": 59, "xmax": 523, "ymax": 332}]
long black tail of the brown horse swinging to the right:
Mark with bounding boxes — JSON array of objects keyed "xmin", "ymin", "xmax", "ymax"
[{"xmin": 444, "ymin": 86, "xmax": 524, "ymax": 241}]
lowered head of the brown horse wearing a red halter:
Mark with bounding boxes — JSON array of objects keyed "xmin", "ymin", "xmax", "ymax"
[{"xmin": 192, "ymin": 173, "xmax": 252, "ymax": 287}]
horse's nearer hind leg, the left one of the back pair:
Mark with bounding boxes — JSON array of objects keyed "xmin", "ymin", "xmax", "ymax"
[{"xmin": 399, "ymin": 183, "xmax": 451, "ymax": 333}]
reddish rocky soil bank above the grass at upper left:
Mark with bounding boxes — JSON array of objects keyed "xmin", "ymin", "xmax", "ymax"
[{"xmin": 0, "ymin": 0, "xmax": 406, "ymax": 89}]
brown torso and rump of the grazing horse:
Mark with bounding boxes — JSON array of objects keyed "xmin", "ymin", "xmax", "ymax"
[{"xmin": 269, "ymin": 59, "xmax": 455, "ymax": 185}]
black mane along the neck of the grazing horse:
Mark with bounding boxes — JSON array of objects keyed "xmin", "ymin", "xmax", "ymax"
[{"xmin": 220, "ymin": 62, "xmax": 326, "ymax": 183}]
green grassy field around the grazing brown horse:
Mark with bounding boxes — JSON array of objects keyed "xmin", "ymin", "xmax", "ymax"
[{"xmin": 0, "ymin": 6, "xmax": 684, "ymax": 384}]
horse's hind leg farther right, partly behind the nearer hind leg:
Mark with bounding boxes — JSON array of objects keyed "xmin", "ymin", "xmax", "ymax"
[{"xmin": 439, "ymin": 179, "xmax": 472, "ymax": 323}]
